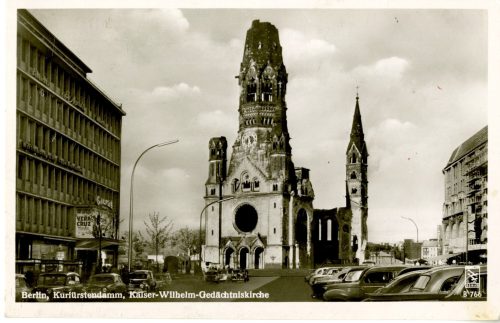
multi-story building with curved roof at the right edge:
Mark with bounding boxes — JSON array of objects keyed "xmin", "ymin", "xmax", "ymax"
[{"xmin": 442, "ymin": 126, "xmax": 488, "ymax": 260}]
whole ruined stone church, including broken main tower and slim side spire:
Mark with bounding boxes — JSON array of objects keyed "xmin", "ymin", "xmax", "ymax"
[{"xmin": 202, "ymin": 20, "xmax": 368, "ymax": 269}]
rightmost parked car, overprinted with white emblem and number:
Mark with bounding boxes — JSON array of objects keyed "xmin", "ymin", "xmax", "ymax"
[{"xmin": 442, "ymin": 265, "xmax": 488, "ymax": 301}]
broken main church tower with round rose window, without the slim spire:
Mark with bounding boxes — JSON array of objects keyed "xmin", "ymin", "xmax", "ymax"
[{"xmin": 202, "ymin": 20, "xmax": 314, "ymax": 268}]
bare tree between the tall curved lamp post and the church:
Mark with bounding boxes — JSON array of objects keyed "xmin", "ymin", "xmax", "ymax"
[{"xmin": 144, "ymin": 212, "xmax": 173, "ymax": 271}]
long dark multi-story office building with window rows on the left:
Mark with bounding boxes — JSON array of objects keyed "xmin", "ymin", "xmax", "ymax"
[{"xmin": 16, "ymin": 10, "xmax": 125, "ymax": 280}]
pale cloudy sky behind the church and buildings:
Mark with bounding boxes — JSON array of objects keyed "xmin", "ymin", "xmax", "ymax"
[{"xmin": 30, "ymin": 9, "xmax": 488, "ymax": 242}]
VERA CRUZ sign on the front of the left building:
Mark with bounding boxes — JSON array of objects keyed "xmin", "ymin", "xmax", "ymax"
[{"xmin": 75, "ymin": 207, "xmax": 115, "ymax": 238}]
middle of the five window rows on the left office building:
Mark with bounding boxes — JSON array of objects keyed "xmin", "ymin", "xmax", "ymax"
[{"xmin": 18, "ymin": 115, "xmax": 120, "ymax": 189}]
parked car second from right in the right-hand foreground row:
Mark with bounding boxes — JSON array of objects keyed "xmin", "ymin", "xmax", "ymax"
[{"xmin": 367, "ymin": 266, "xmax": 464, "ymax": 302}]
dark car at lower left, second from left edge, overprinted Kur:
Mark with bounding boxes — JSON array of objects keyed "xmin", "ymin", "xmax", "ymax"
[{"xmin": 32, "ymin": 272, "xmax": 83, "ymax": 302}]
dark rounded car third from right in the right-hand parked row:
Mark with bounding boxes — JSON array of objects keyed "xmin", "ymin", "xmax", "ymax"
[{"xmin": 323, "ymin": 266, "xmax": 406, "ymax": 302}]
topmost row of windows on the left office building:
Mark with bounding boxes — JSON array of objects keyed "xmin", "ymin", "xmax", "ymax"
[{"xmin": 17, "ymin": 35, "xmax": 121, "ymax": 136}]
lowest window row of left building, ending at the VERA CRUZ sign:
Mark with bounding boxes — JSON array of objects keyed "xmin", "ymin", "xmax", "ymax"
[{"xmin": 16, "ymin": 194, "xmax": 73, "ymax": 236}]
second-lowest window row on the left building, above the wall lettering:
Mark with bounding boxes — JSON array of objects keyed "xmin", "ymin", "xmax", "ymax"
[{"xmin": 17, "ymin": 154, "xmax": 118, "ymax": 204}]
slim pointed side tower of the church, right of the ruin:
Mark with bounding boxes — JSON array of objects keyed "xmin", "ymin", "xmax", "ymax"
[{"xmin": 346, "ymin": 94, "xmax": 368, "ymax": 263}]
